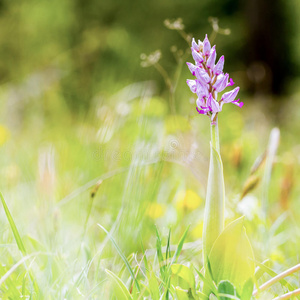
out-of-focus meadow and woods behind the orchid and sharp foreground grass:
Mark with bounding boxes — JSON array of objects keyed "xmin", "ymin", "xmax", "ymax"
[{"xmin": 0, "ymin": 0, "xmax": 300, "ymax": 299}]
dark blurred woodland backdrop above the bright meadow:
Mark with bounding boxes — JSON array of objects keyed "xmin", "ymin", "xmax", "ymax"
[{"xmin": 0, "ymin": 0, "xmax": 300, "ymax": 110}]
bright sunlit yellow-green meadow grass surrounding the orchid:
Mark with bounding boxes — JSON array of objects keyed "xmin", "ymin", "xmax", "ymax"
[{"xmin": 0, "ymin": 83, "xmax": 300, "ymax": 299}]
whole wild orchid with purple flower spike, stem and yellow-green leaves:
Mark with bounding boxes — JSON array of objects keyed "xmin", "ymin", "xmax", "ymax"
[{"xmin": 187, "ymin": 35, "xmax": 254, "ymax": 299}]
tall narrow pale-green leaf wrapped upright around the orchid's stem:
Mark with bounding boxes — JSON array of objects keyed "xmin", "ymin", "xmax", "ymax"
[{"xmin": 203, "ymin": 144, "xmax": 225, "ymax": 265}]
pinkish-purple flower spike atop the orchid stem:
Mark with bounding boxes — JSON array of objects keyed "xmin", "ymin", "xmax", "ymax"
[{"xmin": 187, "ymin": 35, "xmax": 244, "ymax": 124}]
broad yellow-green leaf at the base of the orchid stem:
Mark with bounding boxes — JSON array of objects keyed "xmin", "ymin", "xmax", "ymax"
[{"xmin": 209, "ymin": 217, "xmax": 255, "ymax": 295}]
